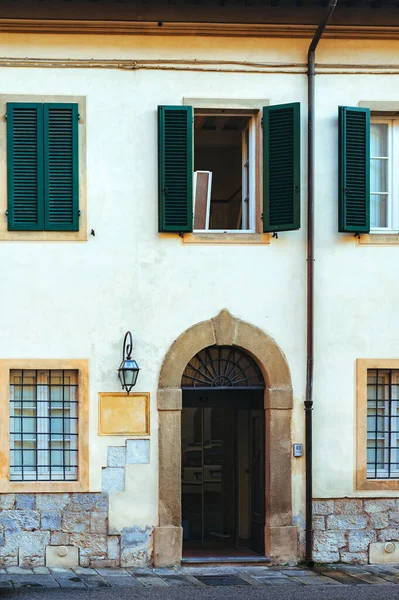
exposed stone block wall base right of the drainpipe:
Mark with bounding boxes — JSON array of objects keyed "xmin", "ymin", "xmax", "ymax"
[{"xmin": 313, "ymin": 498, "xmax": 399, "ymax": 564}]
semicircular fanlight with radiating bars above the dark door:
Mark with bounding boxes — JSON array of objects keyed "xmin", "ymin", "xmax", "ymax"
[{"xmin": 181, "ymin": 346, "xmax": 265, "ymax": 389}]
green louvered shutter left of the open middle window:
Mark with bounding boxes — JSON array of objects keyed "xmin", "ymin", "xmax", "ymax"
[{"xmin": 158, "ymin": 106, "xmax": 193, "ymax": 233}]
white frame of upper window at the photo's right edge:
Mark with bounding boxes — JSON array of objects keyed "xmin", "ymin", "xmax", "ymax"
[{"xmin": 370, "ymin": 113, "xmax": 399, "ymax": 235}]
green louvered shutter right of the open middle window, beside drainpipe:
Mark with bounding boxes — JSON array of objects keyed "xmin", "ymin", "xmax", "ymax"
[{"xmin": 263, "ymin": 102, "xmax": 301, "ymax": 232}]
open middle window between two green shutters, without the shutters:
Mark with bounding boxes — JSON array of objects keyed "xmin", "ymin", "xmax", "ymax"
[{"xmin": 194, "ymin": 110, "xmax": 256, "ymax": 233}]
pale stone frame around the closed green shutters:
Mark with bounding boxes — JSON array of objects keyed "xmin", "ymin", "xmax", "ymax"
[{"xmin": 0, "ymin": 94, "xmax": 88, "ymax": 242}]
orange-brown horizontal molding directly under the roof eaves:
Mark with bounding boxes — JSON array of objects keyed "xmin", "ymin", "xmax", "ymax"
[{"xmin": 0, "ymin": 19, "xmax": 399, "ymax": 40}]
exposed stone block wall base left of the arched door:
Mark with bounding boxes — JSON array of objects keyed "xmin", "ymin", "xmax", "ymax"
[{"xmin": 0, "ymin": 493, "xmax": 152, "ymax": 568}]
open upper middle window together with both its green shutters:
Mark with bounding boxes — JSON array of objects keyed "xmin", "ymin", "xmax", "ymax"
[{"xmin": 158, "ymin": 103, "xmax": 300, "ymax": 235}]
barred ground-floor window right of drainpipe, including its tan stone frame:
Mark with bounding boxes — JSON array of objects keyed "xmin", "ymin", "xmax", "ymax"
[{"xmin": 356, "ymin": 359, "xmax": 399, "ymax": 490}]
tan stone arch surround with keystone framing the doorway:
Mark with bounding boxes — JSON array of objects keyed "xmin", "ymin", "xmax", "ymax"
[{"xmin": 154, "ymin": 309, "xmax": 297, "ymax": 566}]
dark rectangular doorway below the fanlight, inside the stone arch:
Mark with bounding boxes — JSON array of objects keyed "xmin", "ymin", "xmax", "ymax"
[{"xmin": 182, "ymin": 390, "xmax": 265, "ymax": 554}]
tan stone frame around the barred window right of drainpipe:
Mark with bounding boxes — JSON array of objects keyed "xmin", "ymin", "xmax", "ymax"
[{"xmin": 355, "ymin": 359, "xmax": 399, "ymax": 491}]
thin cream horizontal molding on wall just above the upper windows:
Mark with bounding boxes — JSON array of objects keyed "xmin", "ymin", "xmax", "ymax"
[{"xmin": 0, "ymin": 57, "xmax": 399, "ymax": 75}]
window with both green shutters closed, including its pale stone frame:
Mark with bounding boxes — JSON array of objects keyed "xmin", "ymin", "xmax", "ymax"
[{"xmin": 0, "ymin": 96, "xmax": 87, "ymax": 241}]
